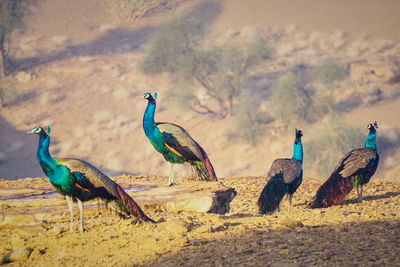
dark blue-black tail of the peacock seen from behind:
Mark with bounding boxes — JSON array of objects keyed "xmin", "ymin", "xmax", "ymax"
[{"xmin": 257, "ymin": 173, "xmax": 289, "ymax": 214}]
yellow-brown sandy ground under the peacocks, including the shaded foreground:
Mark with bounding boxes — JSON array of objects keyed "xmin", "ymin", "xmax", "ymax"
[{"xmin": 0, "ymin": 176, "xmax": 400, "ymax": 266}]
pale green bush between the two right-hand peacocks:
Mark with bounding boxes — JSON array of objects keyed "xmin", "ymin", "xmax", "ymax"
[{"xmin": 304, "ymin": 115, "xmax": 367, "ymax": 179}]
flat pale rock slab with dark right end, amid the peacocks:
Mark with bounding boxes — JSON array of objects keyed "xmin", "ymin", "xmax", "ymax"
[{"xmin": 132, "ymin": 181, "xmax": 237, "ymax": 214}]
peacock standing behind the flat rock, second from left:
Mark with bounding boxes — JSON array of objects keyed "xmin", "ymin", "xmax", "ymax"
[{"xmin": 143, "ymin": 93, "xmax": 218, "ymax": 185}]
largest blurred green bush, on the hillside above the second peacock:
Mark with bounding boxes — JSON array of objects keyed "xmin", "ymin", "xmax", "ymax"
[{"xmin": 139, "ymin": 17, "xmax": 272, "ymax": 119}]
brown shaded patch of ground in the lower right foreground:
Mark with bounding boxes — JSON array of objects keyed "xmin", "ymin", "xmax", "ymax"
[{"xmin": 144, "ymin": 220, "xmax": 400, "ymax": 266}]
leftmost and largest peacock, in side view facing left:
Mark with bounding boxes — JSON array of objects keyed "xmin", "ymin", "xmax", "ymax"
[{"xmin": 28, "ymin": 126, "xmax": 154, "ymax": 232}]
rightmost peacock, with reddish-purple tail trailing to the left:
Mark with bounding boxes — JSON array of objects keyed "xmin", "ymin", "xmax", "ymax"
[{"xmin": 310, "ymin": 121, "xmax": 379, "ymax": 208}]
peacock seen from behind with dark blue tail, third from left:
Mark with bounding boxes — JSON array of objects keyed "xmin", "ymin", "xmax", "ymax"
[{"xmin": 257, "ymin": 129, "xmax": 303, "ymax": 214}]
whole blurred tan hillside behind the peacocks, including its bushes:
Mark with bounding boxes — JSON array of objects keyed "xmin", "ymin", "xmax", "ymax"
[{"xmin": 0, "ymin": 0, "xmax": 400, "ymax": 179}]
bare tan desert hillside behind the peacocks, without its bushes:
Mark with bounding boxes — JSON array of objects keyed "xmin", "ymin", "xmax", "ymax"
[{"xmin": 0, "ymin": 0, "xmax": 400, "ymax": 182}]
